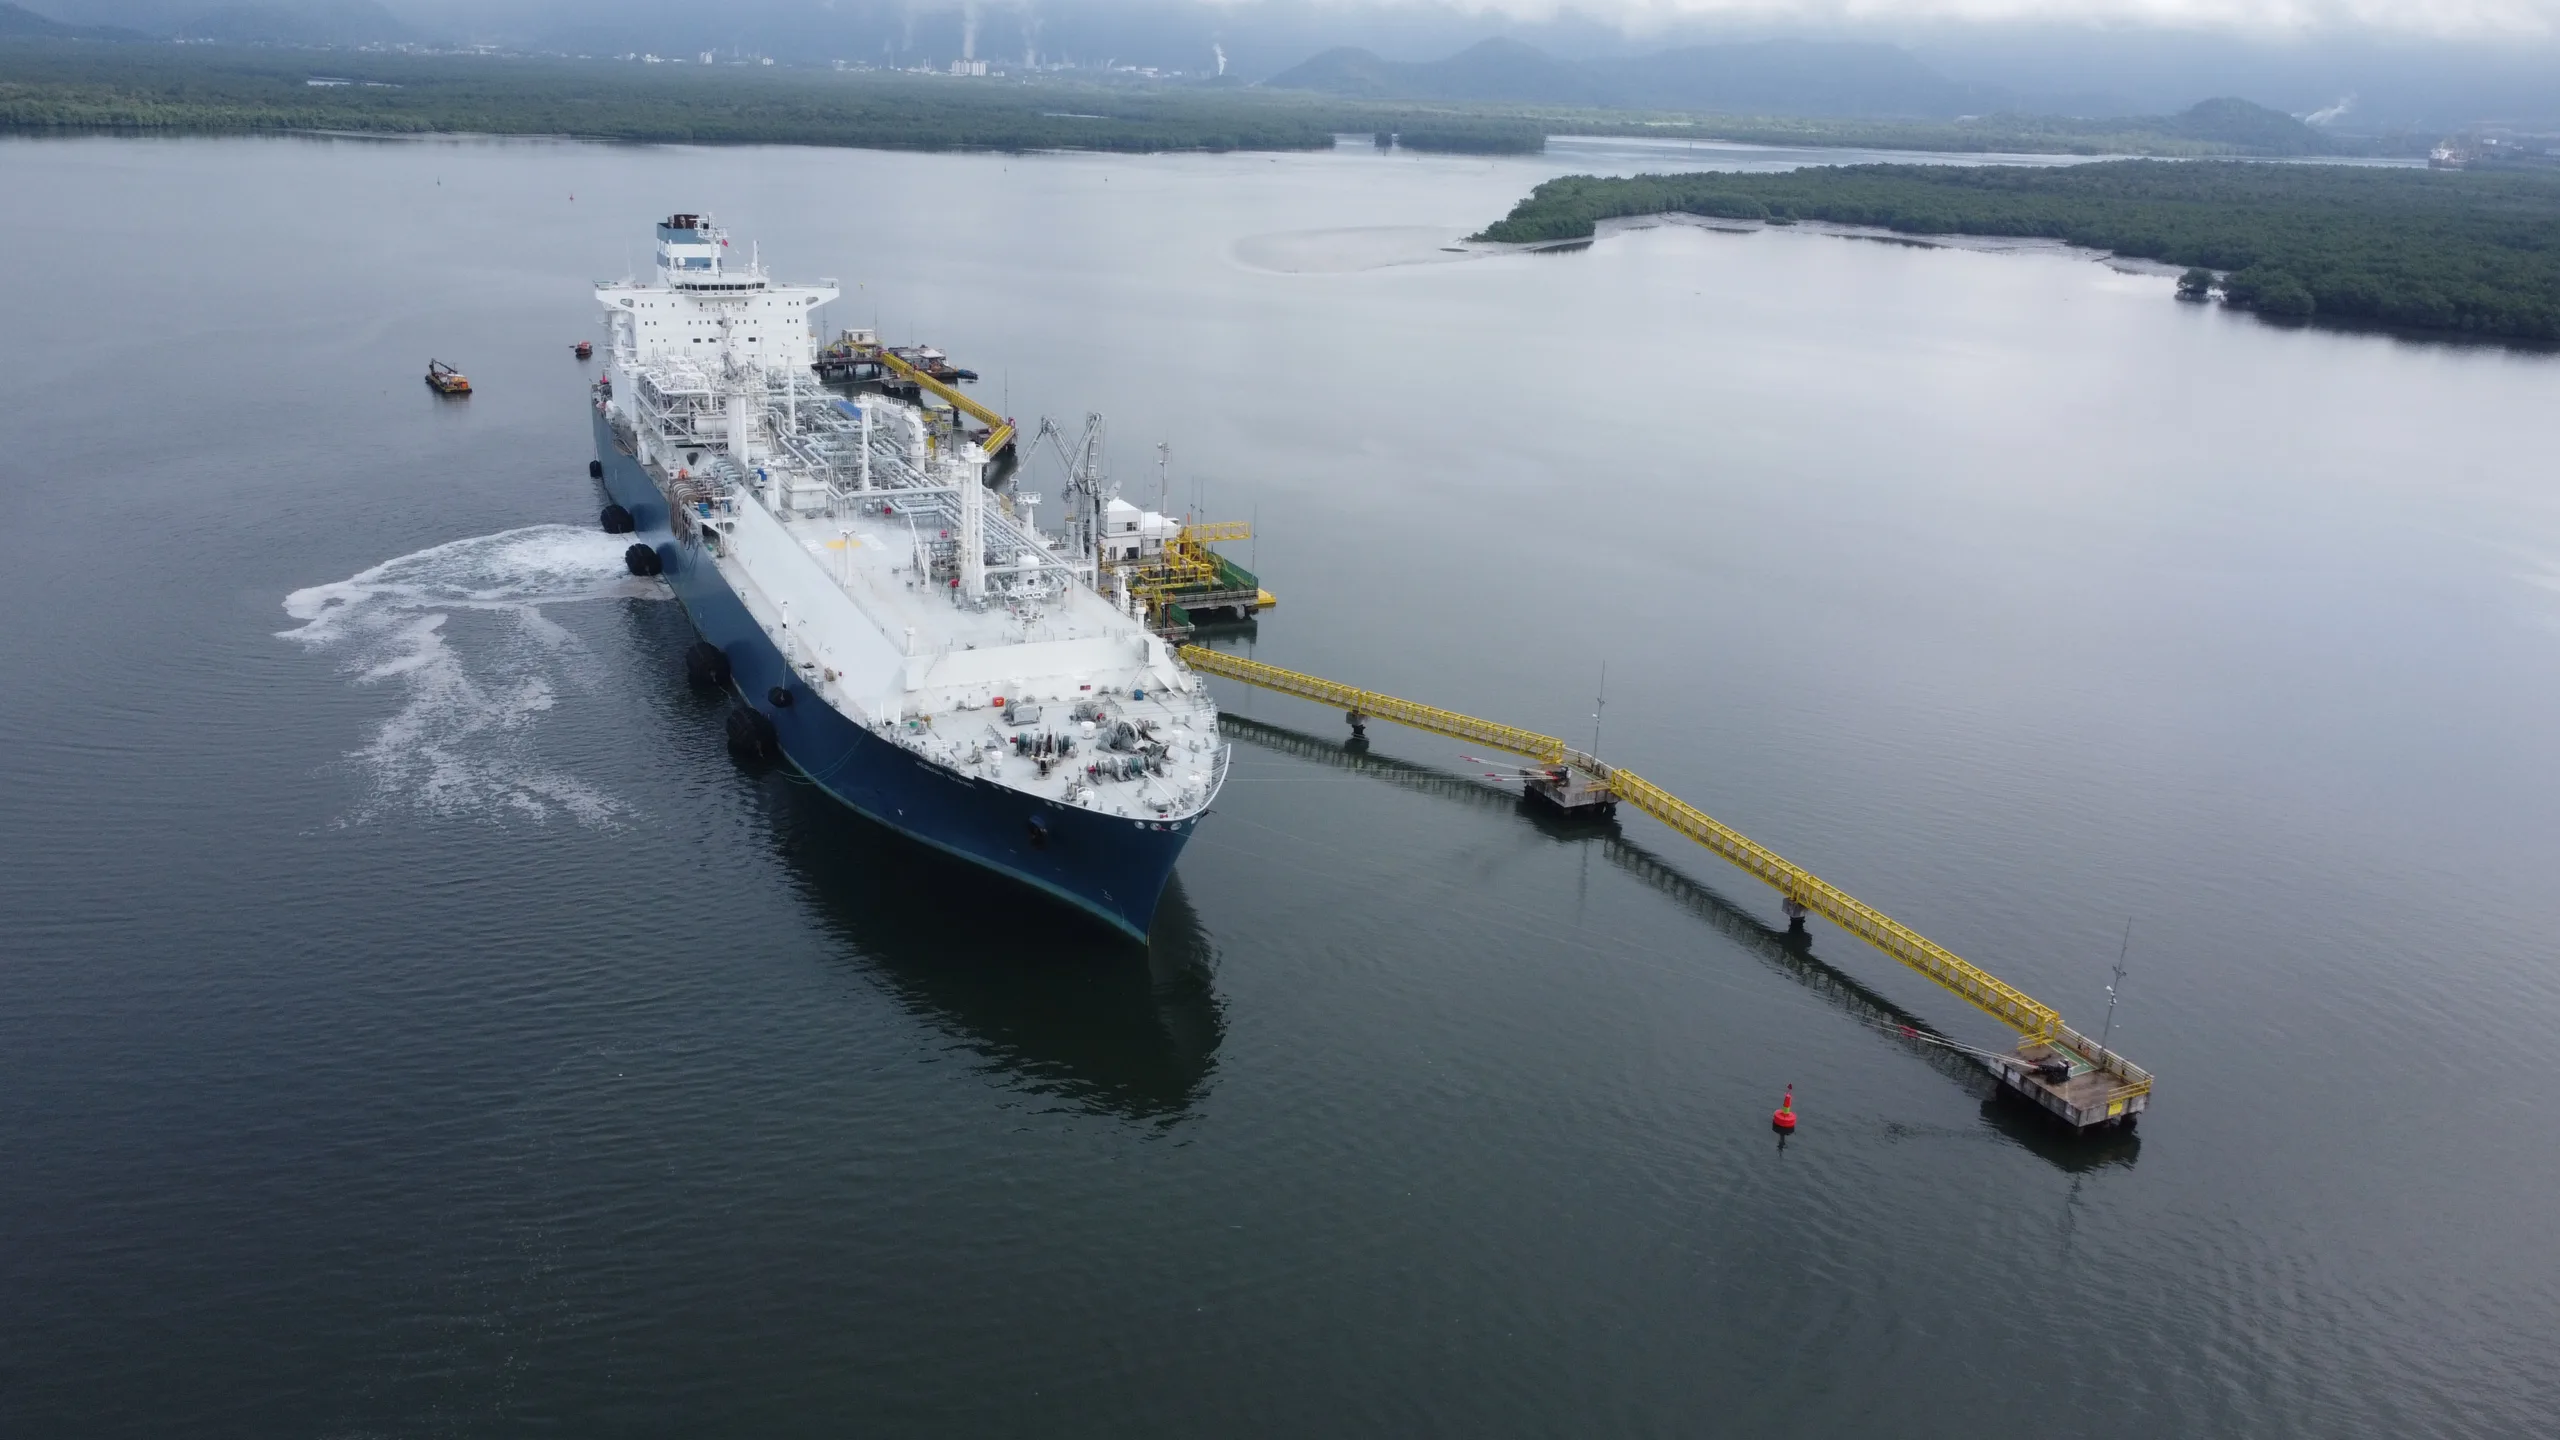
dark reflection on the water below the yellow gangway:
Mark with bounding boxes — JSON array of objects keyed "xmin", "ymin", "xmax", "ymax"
[{"xmin": 1219, "ymin": 715, "xmax": 2143, "ymax": 1171}]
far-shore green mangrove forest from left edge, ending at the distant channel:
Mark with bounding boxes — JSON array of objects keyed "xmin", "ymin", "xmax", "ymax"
[{"xmin": 0, "ymin": 41, "xmax": 1546, "ymax": 151}]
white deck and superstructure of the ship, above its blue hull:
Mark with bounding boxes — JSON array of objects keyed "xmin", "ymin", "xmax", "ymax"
[{"xmin": 596, "ymin": 215, "xmax": 1226, "ymax": 855}]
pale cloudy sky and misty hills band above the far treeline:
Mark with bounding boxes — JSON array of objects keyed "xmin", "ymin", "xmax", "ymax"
[{"xmin": 18, "ymin": 0, "xmax": 2560, "ymax": 131}]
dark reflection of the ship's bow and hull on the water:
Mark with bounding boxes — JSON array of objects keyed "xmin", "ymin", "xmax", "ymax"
[{"xmin": 763, "ymin": 769, "xmax": 1224, "ymax": 1125}]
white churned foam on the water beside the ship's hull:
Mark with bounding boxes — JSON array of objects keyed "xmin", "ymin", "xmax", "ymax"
[{"xmin": 279, "ymin": 525, "xmax": 666, "ymax": 825}]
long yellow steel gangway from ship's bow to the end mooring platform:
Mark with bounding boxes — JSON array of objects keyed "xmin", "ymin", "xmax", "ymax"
[{"xmin": 1183, "ymin": 646, "xmax": 2150, "ymax": 1130}]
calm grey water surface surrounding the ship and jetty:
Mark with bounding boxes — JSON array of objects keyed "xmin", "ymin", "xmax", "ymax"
[{"xmin": 0, "ymin": 141, "xmax": 2560, "ymax": 1437}]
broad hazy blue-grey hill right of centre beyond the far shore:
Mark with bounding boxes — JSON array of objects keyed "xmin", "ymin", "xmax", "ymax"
[{"xmin": 1265, "ymin": 38, "xmax": 1976, "ymax": 115}]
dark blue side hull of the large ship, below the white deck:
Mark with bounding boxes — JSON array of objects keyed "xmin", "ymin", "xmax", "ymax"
[{"xmin": 594, "ymin": 407, "xmax": 1198, "ymax": 940}]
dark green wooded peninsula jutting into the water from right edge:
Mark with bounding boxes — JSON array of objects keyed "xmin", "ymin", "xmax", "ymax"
[{"xmin": 1477, "ymin": 159, "xmax": 2560, "ymax": 341}]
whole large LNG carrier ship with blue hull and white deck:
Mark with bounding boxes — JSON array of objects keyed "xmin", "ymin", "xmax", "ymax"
[{"xmin": 589, "ymin": 215, "xmax": 1229, "ymax": 938}]
